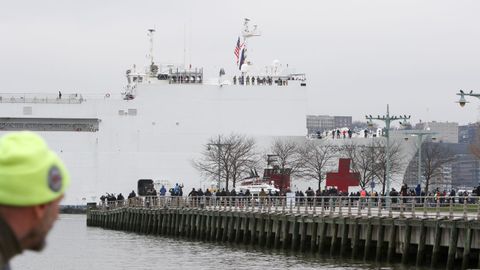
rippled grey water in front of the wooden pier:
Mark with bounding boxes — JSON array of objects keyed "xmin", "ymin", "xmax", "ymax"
[{"xmin": 12, "ymin": 215, "xmax": 420, "ymax": 270}]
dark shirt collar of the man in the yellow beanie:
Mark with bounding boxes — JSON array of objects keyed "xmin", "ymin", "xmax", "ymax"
[{"xmin": 0, "ymin": 216, "xmax": 22, "ymax": 270}]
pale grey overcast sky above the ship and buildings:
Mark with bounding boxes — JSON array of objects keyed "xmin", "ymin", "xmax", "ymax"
[{"xmin": 0, "ymin": 0, "xmax": 480, "ymax": 124}]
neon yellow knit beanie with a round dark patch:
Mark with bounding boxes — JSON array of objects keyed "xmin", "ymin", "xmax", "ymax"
[{"xmin": 0, "ymin": 131, "xmax": 70, "ymax": 206}]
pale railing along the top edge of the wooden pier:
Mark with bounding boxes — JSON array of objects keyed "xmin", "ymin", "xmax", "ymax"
[{"xmin": 99, "ymin": 196, "xmax": 480, "ymax": 220}]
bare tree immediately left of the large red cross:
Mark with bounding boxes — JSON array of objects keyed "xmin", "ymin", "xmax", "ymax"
[{"xmin": 297, "ymin": 141, "xmax": 337, "ymax": 189}]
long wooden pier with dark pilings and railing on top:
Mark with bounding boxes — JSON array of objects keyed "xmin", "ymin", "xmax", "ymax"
[{"xmin": 87, "ymin": 197, "xmax": 480, "ymax": 269}]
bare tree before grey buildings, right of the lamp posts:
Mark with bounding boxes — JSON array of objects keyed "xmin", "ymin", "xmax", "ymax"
[{"xmin": 421, "ymin": 142, "xmax": 455, "ymax": 194}]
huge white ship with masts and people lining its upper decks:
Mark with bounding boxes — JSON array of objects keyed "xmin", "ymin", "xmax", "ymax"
[{"xmin": 0, "ymin": 19, "xmax": 307, "ymax": 204}]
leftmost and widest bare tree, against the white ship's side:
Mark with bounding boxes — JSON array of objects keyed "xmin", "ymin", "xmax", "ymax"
[{"xmin": 193, "ymin": 134, "xmax": 258, "ymax": 190}]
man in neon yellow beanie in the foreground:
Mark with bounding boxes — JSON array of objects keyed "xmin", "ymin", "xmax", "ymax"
[{"xmin": 0, "ymin": 131, "xmax": 70, "ymax": 270}]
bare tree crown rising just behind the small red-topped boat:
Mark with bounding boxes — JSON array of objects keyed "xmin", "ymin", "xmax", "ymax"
[{"xmin": 270, "ymin": 139, "xmax": 303, "ymax": 176}]
